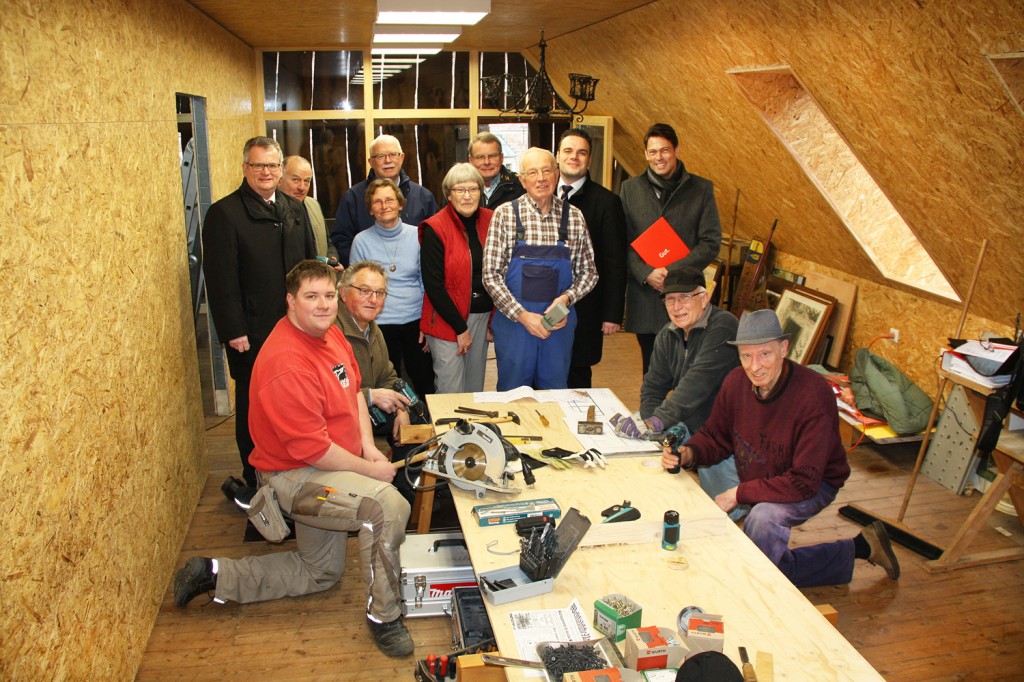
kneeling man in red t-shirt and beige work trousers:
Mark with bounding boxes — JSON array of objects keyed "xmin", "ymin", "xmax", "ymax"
[{"xmin": 174, "ymin": 260, "xmax": 413, "ymax": 656}]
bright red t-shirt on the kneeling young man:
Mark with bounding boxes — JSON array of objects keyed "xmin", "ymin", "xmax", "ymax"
[{"xmin": 249, "ymin": 317, "xmax": 362, "ymax": 471}]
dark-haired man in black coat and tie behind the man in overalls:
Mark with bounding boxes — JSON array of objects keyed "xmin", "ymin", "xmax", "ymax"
[{"xmin": 557, "ymin": 128, "xmax": 626, "ymax": 388}]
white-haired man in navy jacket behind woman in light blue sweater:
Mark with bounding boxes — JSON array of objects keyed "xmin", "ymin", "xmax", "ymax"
[{"xmin": 331, "ymin": 135, "xmax": 437, "ymax": 266}]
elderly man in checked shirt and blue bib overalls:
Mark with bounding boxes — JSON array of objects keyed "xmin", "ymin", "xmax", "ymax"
[{"xmin": 483, "ymin": 147, "xmax": 597, "ymax": 391}]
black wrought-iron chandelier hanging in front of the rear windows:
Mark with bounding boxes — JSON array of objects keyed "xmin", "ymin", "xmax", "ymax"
[{"xmin": 480, "ymin": 29, "xmax": 598, "ymax": 122}]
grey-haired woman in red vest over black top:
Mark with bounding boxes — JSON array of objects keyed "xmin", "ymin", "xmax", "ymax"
[{"xmin": 420, "ymin": 164, "xmax": 495, "ymax": 393}]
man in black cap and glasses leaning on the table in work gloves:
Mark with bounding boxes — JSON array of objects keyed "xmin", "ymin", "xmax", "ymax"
[{"xmin": 616, "ymin": 265, "xmax": 746, "ymax": 520}]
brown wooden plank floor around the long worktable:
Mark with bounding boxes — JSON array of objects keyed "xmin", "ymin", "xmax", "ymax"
[{"xmin": 137, "ymin": 333, "xmax": 1024, "ymax": 682}]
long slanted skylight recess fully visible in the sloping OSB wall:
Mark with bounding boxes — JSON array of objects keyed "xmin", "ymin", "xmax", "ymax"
[{"xmin": 730, "ymin": 67, "xmax": 959, "ymax": 301}]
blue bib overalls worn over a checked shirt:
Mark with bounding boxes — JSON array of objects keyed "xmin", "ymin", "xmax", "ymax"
[{"xmin": 490, "ymin": 200, "xmax": 577, "ymax": 391}]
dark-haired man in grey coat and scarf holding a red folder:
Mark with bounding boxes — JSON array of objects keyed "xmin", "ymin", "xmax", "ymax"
[{"xmin": 621, "ymin": 123, "xmax": 722, "ymax": 374}]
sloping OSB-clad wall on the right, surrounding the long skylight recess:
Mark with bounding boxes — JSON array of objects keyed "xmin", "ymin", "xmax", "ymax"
[{"xmin": 535, "ymin": 0, "xmax": 1024, "ymax": 323}]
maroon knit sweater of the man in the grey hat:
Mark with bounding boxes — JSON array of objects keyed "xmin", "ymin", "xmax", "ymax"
[{"xmin": 686, "ymin": 360, "xmax": 850, "ymax": 504}]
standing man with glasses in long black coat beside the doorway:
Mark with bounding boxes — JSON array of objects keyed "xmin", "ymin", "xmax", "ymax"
[{"xmin": 203, "ymin": 137, "xmax": 316, "ymax": 493}]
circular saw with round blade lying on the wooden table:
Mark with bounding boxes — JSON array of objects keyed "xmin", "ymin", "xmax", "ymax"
[{"xmin": 423, "ymin": 420, "xmax": 520, "ymax": 498}]
